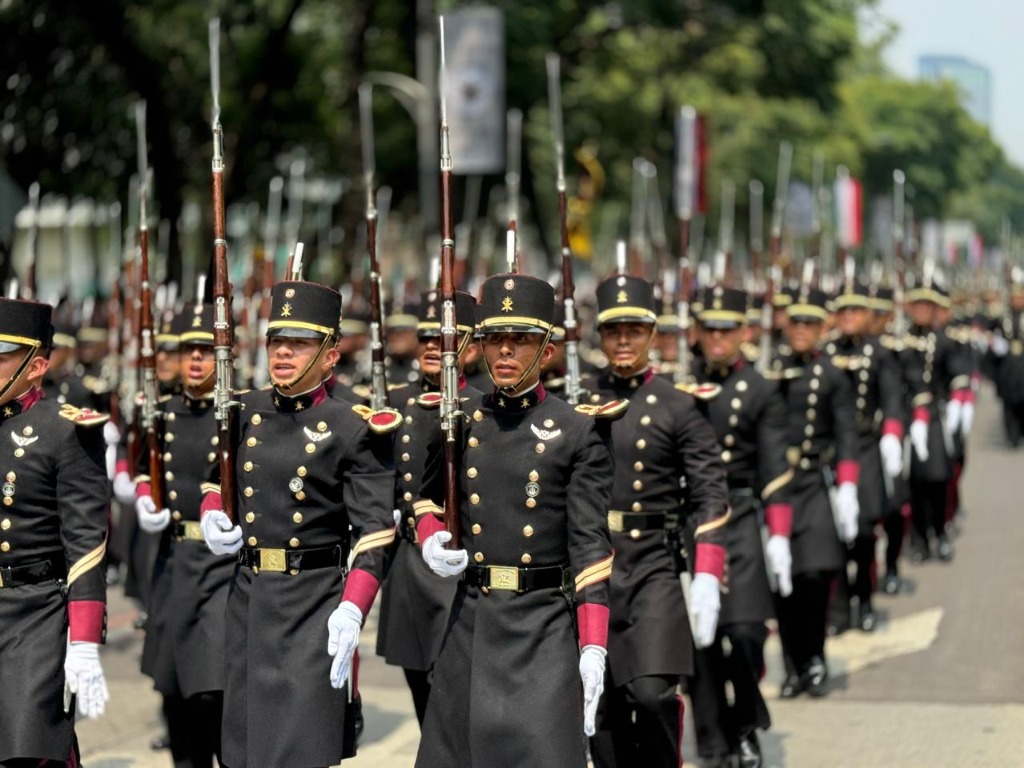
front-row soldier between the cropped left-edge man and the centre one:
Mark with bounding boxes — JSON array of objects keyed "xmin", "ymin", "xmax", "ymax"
[{"xmin": 201, "ymin": 281, "xmax": 394, "ymax": 768}]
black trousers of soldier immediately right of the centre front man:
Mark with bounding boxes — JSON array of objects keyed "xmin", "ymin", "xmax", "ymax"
[{"xmin": 591, "ymin": 675, "xmax": 683, "ymax": 768}]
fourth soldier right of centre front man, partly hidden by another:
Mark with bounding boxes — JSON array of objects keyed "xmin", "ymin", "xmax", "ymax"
[{"xmin": 825, "ymin": 280, "xmax": 903, "ymax": 632}]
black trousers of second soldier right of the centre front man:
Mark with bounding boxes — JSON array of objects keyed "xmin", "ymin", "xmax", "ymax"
[{"xmin": 688, "ymin": 623, "xmax": 771, "ymax": 758}]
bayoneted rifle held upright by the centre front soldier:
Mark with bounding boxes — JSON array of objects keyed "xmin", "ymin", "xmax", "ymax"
[{"xmin": 438, "ymin": 15, "xmax": 460, "ymax": 549}]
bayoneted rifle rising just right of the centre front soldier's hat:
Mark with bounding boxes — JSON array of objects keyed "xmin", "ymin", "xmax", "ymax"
[{"xmin": 547, "ymin": 53, "xmax": 583, "ymax": 406}]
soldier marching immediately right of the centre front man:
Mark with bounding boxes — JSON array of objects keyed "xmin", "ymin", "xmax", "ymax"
[{"xmin": 586, "ymin": 274, "xmax": 729, "ymax": 768}]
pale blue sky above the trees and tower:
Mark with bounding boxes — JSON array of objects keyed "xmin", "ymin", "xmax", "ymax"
[{"xmin": 876, "ymin": 0, "xmax": 1024, "ymax": 167}]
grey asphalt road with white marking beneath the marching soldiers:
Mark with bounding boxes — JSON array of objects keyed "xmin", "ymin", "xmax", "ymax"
[{"xmin": 79, "ymin": 385, "xmax": 1024, "ymax": 768}]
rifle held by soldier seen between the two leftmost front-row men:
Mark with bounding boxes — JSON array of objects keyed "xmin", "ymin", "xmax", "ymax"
[{"xmin": 135, "ymin": 101, "xmax": 164, "ymax": 510}]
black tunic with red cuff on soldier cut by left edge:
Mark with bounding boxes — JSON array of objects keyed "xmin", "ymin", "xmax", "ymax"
[{"xmin": 0, "ymin": 389, "xmax": 109, "ymax": 764}]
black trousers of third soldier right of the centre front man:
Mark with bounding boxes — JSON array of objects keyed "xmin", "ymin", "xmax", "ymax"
[{"xmin": 776, "ymin": 570, "xmax": 836, "ymax": 674}]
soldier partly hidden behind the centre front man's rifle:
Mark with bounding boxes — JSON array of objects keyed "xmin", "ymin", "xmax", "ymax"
[{"xmin": 377, "ymin": 291, "xmax": 480, "ymax": 726}]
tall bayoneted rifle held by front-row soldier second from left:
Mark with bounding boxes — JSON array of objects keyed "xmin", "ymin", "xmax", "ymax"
[{"xmin": 208, "ymin": 18, "xmax": 240, "ymax": 521}]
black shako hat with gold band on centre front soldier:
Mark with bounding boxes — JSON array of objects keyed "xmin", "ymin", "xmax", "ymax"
[{"xmin": 477, "ymin": 272, "xmax": 555, "ymax": 334}]
